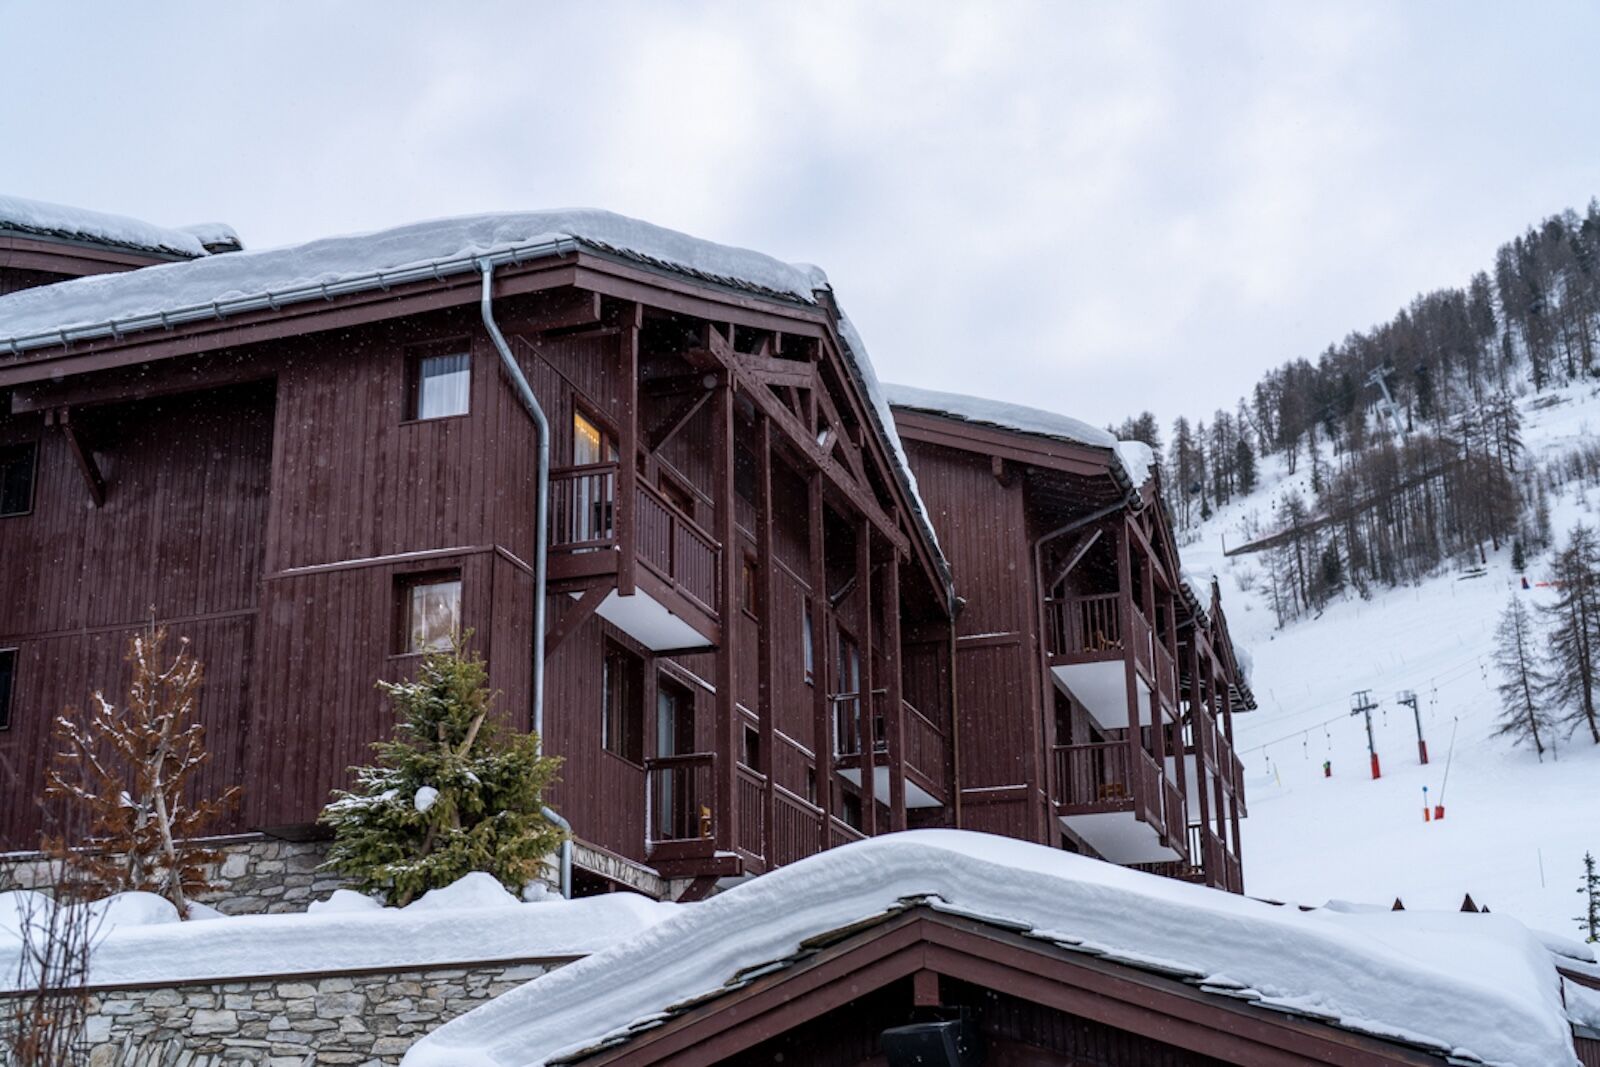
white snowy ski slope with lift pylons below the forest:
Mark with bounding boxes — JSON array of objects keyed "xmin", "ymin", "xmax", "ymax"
[{"xmin": 1182, "ymin": 386, "xmax": 1600, "ymax": 936}]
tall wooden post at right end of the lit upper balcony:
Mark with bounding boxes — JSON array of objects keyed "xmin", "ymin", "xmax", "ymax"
[{"xmin": 712, "ymin": 378, "xmax": 739, "ymax": 853}]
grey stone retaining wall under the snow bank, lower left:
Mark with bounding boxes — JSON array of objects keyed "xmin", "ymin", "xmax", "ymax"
[{"xmin": 70, "ymin": 958, "xmax": 571, "ymax": 1067}]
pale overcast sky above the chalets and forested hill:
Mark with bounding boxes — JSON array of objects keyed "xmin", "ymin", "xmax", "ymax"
[{"xmin": 0, "ymin": 0, "xmax": 1600, "ymax": 426}]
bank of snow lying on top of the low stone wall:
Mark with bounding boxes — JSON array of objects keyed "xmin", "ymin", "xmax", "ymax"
[{"xmin": 0, "ymin": 873, "xmax": 680, "ymax": 990}]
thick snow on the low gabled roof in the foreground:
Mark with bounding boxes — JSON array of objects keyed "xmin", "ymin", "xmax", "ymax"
[{"xmin": 405, "ymin": 830, "xmax": 1574, "ymax": 1067}]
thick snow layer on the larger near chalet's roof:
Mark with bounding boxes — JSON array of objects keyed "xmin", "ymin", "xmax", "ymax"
[{"xmin": 0, "ymin": 208, "xmax": 949, "ymax": 592}]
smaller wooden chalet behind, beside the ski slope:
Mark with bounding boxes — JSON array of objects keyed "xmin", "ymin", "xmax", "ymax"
[{"xmin": 890, "ymin": 387, "xmax": 1253, "ymax": 893}]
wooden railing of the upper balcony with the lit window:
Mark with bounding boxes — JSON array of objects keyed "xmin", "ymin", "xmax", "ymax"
[{"xmin": 550, "ymin": 462, "xmax": 722, "ymax": 614}]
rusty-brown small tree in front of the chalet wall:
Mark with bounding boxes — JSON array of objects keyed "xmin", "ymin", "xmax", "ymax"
[{"xmin": 43, "ymin": 625, "xmax": 238, "ymax": 918}]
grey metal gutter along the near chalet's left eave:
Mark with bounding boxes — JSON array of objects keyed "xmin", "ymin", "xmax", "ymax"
[{"xmin": 0, "ymin": 237, "xmax": 579, "ymax": 355}]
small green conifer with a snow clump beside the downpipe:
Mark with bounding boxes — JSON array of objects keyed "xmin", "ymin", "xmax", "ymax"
[{"xmin": 322, "ymin": 640, "xmax": 562, "ymax": 907}]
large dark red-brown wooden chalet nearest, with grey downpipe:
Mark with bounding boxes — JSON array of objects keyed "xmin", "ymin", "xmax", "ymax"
[{"xmin": 0, "ymin": 213, "xmax": 954, "ymax": 888}]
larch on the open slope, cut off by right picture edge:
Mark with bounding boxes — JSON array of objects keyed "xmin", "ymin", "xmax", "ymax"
[{"xmin": 1542, "ymin": 525, "xmax": 1600, "ymax": 744}]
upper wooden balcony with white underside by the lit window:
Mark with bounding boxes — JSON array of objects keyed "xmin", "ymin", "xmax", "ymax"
[{"xmin": 549, "ymin": 462, "xmax": 722, "ymax": 651}]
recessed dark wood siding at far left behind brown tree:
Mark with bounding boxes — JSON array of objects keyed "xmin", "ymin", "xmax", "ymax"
[{"xmin": 0, "ymin": 382, "xmax": 274, "ymax": 848}]
